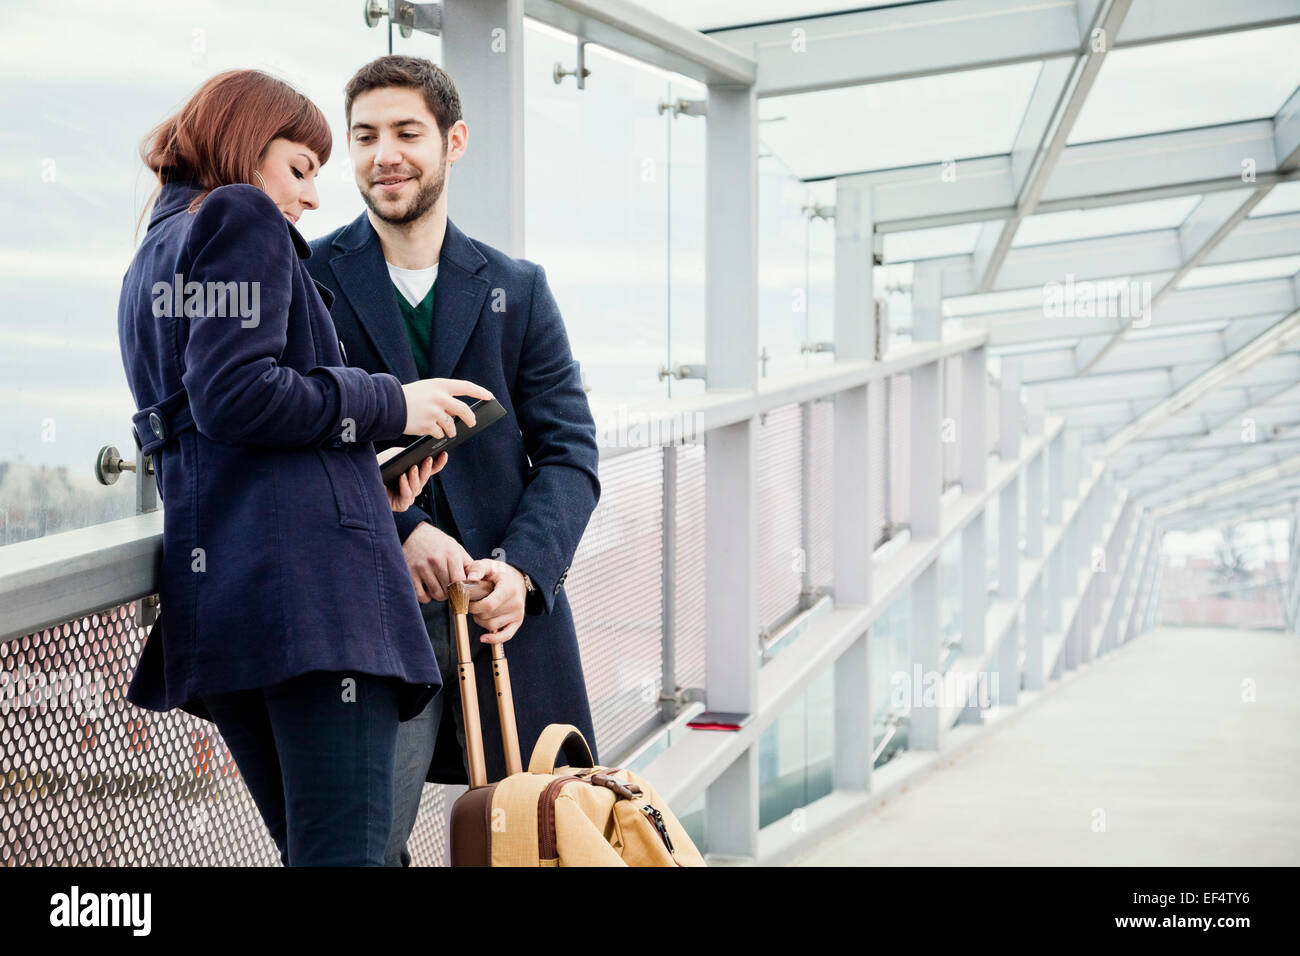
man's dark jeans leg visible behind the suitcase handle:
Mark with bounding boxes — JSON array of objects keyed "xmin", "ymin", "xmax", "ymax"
[{"xmin": 384, "ymin": 601, "xmax": 468, "ymax": 866}]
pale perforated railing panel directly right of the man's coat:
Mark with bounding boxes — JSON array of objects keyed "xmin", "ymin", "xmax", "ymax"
[{"xmin": 564, "ymin": 447, "xmax": 663, "ymax": 753}]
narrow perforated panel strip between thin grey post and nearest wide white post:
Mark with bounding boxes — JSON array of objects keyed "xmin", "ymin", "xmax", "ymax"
[{"xmin": 673, "ymin": 442, "xmax": 707, "ymax": 687}]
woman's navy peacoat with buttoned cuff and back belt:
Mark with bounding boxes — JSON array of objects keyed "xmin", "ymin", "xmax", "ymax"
[{"xmin": 117, "ymin": 182, "xmax": 442, "ymax": 719}]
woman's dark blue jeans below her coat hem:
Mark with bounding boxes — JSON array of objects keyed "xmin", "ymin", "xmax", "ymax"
[{"xmin": 203, "ymin": 671, "xmax": 400, "ymax": 866}]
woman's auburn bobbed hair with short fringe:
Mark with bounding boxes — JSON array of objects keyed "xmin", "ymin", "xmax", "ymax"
[{"xmin": 135, "ymin": 70, "xmax": 334, "ymax": 235}]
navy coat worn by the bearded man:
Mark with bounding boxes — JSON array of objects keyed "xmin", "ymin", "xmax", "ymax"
[{"xmin": 307, "ymin": 212, "xmax": 601, "ymax": 783}]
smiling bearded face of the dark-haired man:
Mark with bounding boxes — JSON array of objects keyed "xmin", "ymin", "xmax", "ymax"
[{"xmin": 347, "ymin": 87, "xmax": 464, "ymax": 225}]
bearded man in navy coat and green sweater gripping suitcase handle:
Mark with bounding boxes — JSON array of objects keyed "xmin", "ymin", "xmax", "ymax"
[{"xmin": 307, "ymin": 56, "xmax": 601, "ymax": 866}]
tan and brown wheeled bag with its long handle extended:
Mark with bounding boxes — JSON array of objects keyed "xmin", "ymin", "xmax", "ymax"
[{"xmin": 447, "ymin": 583, "xmax": 707, "ymax": 866}]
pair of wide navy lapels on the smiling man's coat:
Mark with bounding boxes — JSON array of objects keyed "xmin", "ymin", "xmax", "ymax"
[{"xmin": 330, "ymin": 212, "xmax": 488, "ymax": 382}]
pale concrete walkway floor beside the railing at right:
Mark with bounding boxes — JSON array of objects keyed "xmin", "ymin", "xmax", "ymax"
[{"xmin": 792, "ymin": 628, "xmax": 1300, "ymax": 866}]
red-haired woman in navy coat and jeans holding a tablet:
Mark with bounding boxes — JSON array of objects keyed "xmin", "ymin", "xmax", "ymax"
[{"xmin": 118, "ymin": 70, "xmax": 491, "ymax": 866}]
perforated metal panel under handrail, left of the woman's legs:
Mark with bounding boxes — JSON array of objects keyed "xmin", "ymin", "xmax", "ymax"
[{"xmin": 0, "ymin": 604, "xmax": 280, "ymax": 866}]
